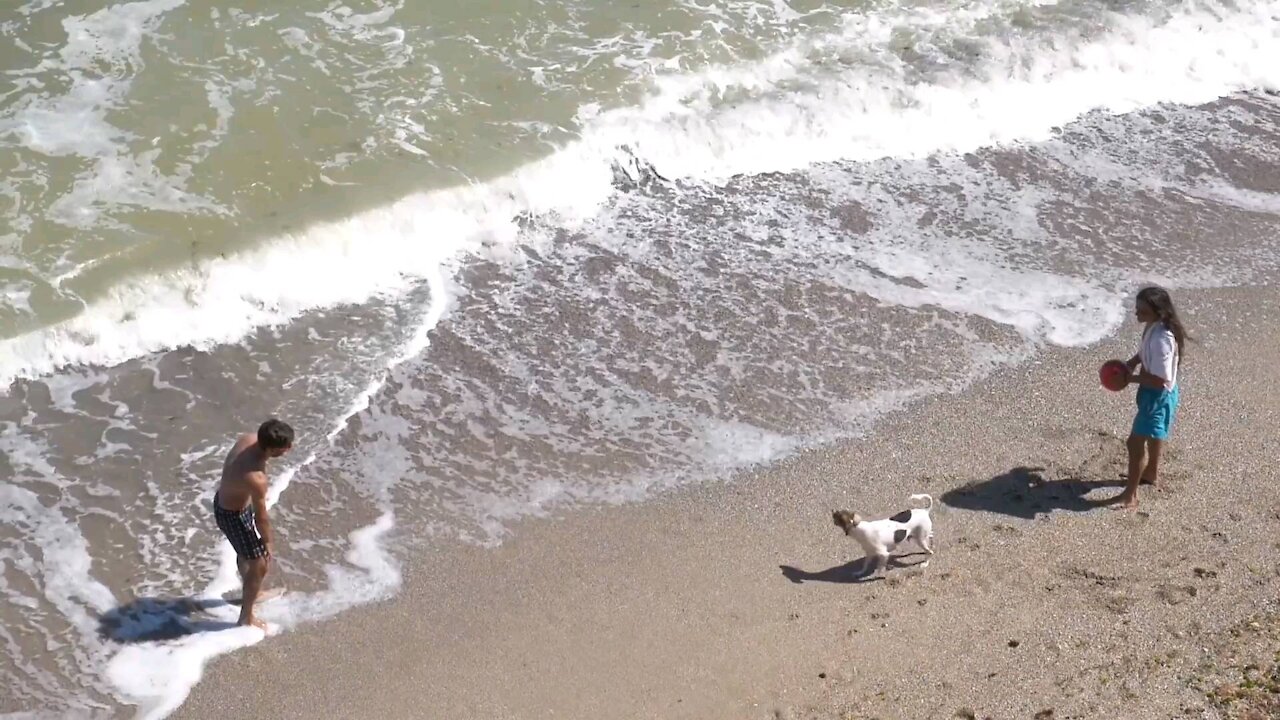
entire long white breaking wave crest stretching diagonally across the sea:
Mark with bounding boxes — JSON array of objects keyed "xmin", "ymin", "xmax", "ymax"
[{"xmin": 0, "ymin": 1, "xmax": 1280, "ymax": 386}]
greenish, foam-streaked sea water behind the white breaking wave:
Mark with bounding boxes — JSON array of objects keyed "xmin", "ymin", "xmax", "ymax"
[{"xmin": 0, "ymin": 0, "xmax": 841, "ymax": 337}]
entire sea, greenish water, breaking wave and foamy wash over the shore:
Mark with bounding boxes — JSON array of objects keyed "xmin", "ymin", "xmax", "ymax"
[{"xmin": 0, "ymin": 0, "xmax": 1280, "ymax": 717}]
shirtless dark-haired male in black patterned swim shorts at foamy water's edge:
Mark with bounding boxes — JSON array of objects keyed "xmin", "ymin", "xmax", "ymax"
[{"xmin": 214, "ymin": 418, "xmax": 293, "ymax": 630}]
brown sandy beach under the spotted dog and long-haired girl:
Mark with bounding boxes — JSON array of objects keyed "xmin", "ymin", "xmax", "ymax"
[{"xmin": 177, "ymin": 290, "xmax": 1280, "ymax": 719}]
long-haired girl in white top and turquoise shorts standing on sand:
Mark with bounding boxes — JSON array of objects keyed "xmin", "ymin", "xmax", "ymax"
[{"xmin": 1115, "ymin": 287, "xmax": 1188, "ymax": 510}]
